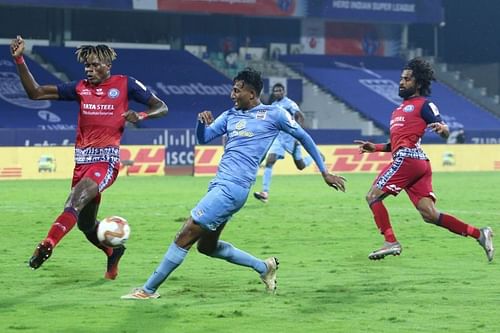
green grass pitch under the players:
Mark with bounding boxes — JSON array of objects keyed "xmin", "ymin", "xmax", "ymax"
[{"xmin": 0, "ymin": 172, "xmax": 500, "ymax": 333}]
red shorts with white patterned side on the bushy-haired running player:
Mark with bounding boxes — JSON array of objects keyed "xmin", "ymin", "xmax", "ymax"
[{"xmin": 373, "ymin": 156, "xmax": 436, "ymax": 206}]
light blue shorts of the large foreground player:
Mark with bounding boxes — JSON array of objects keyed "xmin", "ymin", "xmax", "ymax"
[{"xmin": 191, "ymin": 179, "xmax": 250, "ymax": 231}]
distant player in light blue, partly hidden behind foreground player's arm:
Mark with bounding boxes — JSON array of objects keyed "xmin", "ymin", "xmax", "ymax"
[{"xmin": 253, "ymin": 83, "xmax": 313, "ymax": 203}]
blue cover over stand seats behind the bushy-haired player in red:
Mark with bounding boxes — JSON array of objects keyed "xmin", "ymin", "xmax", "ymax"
[{"xmin": 280, "ymin": 55, "xmax": 500, "ymax": 131}]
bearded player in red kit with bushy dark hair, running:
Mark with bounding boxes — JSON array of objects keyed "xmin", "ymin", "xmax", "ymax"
[{"xmin": 355, "ymin": 58, "xmax": 494, "ymax": 261}]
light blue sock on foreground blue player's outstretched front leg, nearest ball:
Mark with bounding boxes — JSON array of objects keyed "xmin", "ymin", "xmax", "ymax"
[{"xmin": 143, "ymin": 243, "xmax": 188, "ymax": 294}]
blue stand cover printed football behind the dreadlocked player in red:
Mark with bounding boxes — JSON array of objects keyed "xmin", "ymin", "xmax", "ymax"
[{"xmin": 28, "ymin": 46, "xmax": 232, "ymax": 128}]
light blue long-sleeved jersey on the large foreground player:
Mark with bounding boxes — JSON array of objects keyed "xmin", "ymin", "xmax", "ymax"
[{"xmin": 196, "ymin": 104, "xmax": 325, "ymax": 188}]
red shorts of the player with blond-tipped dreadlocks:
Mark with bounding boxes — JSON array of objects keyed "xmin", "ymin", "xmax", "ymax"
[{"xmin": 71, "ymin": 162, "xmax": 118, "ymax": 203}]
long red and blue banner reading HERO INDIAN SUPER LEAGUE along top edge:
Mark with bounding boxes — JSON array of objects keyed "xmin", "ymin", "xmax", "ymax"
[{"xmin": 152, "ymin": 0, "xmax": 444, "ymax": 23}]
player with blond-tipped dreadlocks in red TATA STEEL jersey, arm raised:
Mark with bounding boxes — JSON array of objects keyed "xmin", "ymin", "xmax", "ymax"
[{"xmin": 11, "ymin": 36, "xmax": 168, "ymax": 280}]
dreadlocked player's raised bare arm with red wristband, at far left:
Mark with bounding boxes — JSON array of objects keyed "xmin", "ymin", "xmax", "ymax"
[{"xmin": 10, "ymin": 36, "xmax": 59, "ymax": 100}]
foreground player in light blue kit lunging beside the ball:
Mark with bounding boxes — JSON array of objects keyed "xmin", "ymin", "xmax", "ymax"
[{"xmin": 122, "ymin": 68, "xmax": 345, "ymax": 299}]
